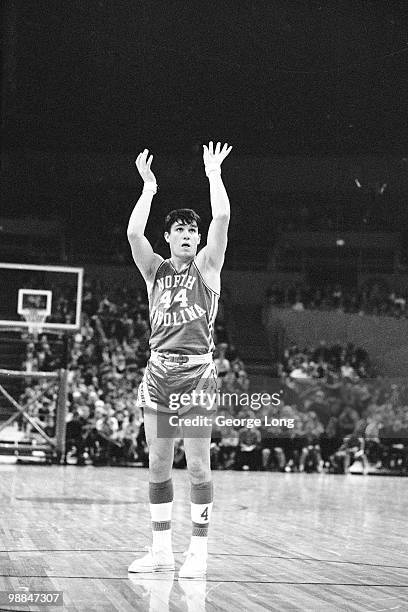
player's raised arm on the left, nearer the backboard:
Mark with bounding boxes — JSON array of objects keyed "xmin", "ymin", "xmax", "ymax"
[{"xmin": 127, "ymin": 149, "xmax": 163, "ymax": 282}]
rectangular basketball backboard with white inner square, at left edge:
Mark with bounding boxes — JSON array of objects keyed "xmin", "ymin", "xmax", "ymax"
[{"xmin": 0, "ymin": 263, "xmax": 83, "ymax": 331}]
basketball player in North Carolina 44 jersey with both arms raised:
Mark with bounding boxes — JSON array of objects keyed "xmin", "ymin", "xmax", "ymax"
[{"xmin": 128, "ymin": 142, "xmax": 232, "ymax": 578}]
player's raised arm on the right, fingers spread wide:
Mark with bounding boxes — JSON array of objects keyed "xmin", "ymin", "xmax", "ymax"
[{"xmin": 199, "ymin": 142, "xmax": 232, "ymax": 272}]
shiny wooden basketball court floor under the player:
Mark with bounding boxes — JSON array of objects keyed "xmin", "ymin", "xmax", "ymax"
[{"xmin": 0, "ymin": 465, "xmax": 408, "ymax": 612}]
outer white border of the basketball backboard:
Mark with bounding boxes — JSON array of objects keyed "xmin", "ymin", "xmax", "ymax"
[{"xmin": 0, "ymin": 263, "xmax": 84, "ymax": 331}]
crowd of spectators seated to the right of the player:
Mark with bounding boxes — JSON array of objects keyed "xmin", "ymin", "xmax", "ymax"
[{"xmin": 163, "ymin": 342, "xmax": 408, "ymax": 473}]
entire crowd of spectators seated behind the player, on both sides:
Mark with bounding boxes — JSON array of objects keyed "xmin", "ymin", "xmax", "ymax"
[{"xmin": 9, "ymin": 281, "xmax": 408, "ymax": 472}]
